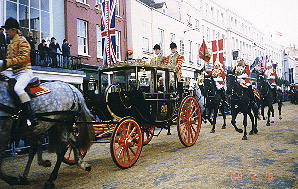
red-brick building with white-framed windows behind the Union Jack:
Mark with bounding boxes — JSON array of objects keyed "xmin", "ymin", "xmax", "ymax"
[{"xmin": 64, "ymin": 0, "xmax": 127, "ymax": 92}]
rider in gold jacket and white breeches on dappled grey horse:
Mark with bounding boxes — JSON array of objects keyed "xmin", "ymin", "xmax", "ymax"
[{"xmin": 0, "ymin": 18, "xmax": 38, "ymax": 127}]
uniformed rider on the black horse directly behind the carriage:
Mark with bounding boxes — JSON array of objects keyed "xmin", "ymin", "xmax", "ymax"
[{"xmin": 208, "ymin": 62, "xmax": 228, "ymax": 105}]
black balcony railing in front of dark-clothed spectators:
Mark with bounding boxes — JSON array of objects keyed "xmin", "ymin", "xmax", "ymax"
[{"xmin": 0, "ymin": 46, "xmax": 81, "ymax": 70}]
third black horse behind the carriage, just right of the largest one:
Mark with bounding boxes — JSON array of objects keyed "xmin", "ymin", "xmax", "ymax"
[{"xmin": 258, "ymin": 74, "xmax": 282, "ymax": 126}]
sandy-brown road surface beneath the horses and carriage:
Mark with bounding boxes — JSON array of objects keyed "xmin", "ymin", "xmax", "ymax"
[{"xmin": 0, "ymin": 103, "xmax": 298, "ymax": 189}]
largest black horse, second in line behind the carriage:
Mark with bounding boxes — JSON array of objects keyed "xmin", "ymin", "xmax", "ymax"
[{"xmin": 227, "ymin": 72, "xmax": 258, "ymax": 140}]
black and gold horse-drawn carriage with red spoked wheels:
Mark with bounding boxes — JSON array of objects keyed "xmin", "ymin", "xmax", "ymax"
[{"xmin": 64, "ymin": 62, "xmax": 201, "ymax": 168}]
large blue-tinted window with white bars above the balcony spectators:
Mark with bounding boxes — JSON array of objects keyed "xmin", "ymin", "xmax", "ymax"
[{"xmin": 5, "ymin": 0, "xmax": 50, "ymax": 42}]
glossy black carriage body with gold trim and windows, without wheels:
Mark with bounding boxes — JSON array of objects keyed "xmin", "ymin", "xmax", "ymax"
[{"xmin": 98, "ymin": 66, "xmax": 177, "ymax": 126}]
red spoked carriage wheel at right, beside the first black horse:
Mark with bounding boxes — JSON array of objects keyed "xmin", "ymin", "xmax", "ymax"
[{"xmin": 177, "ymin": 96, "xmax": 201, "ymax": 147}]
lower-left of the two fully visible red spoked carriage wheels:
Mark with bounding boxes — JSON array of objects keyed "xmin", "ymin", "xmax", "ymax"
[{"xmin": 110, "ymin": 118, "xmax": 143, "ymax": 169}]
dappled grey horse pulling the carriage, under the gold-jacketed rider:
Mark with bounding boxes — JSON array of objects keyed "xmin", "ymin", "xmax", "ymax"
[{"xmin": 0, "ymin": 74, "xmax": 94, "ymax": 188}]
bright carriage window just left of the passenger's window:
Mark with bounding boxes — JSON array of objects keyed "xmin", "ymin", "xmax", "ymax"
[{"xmin": 138, "ymin": 68, "xmax": 154, "ymax": 93}]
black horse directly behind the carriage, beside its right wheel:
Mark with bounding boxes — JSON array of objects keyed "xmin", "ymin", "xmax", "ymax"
[{"xmin": 202, "ymin": 76, "xmax": 226, "ymax": 133}]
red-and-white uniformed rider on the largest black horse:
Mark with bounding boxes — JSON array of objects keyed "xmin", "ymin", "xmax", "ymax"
[{"xmin": 233, "ymin": 59, "xmax": 257, "ymax": 108}]
